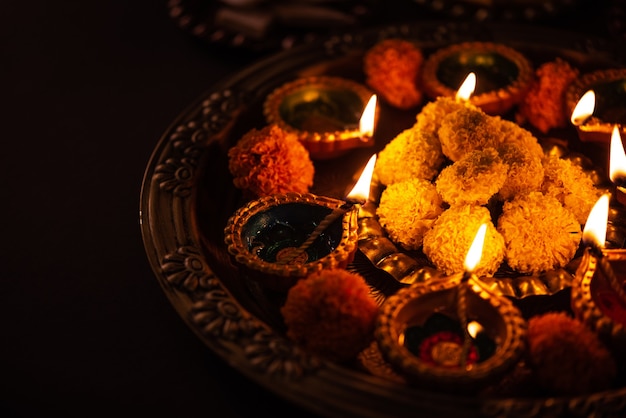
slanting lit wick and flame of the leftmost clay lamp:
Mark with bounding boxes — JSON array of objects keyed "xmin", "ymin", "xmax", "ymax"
[{"xmin": 280, "ymin": 154, "xmax": 376, "ymax": 264}]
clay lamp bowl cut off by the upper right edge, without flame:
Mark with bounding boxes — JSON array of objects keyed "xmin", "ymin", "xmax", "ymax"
[{"xmin": 565, "ymin": 68, "xmax": 626, "ymax": 144}]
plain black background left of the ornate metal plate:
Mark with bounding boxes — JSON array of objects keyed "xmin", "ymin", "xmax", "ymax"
[{"xmin": 0, "ymin": 0, "xmax": 623, "ymax": 417}]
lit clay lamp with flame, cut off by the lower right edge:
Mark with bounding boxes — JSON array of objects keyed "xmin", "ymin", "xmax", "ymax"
[{"xmin": 571, "ymin": 194, "xmax": 626, "ymax": 354}]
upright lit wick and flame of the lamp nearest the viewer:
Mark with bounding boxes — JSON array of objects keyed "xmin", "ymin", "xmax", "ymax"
[{"xmin": 457, "ymin": 224, "xmax": 487, "ymax": 368}]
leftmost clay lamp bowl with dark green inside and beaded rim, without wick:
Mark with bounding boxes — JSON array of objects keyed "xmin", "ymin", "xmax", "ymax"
[{"xmin": 224, "ymin": 193, "xmax": 358, "ymax": 291}]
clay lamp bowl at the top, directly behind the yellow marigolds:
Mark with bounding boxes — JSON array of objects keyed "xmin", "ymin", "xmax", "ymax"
[{"xmin": 422, "ymin": 42, "xmax": 534, "ymax": 115}]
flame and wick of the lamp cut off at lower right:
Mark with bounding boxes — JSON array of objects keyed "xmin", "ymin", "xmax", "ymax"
[{"xmin": 583, "ymin": 193, "xmax": 626, "ymax": 300}]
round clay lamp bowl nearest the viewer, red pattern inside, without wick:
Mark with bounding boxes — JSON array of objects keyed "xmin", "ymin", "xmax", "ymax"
[{"xmin": 375, "ymin": 276, "xmax": 526, "ymax": 393}]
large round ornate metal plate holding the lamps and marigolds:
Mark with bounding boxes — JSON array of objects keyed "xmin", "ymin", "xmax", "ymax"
[{"xmin": 140, "ymin": 23, "xmax": 626, "ymax": 417}]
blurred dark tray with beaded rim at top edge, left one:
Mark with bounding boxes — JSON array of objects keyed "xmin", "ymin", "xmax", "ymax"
[{"xmin": 168, "ymin": 0, "xmax": 380, "ymax": 52}]
